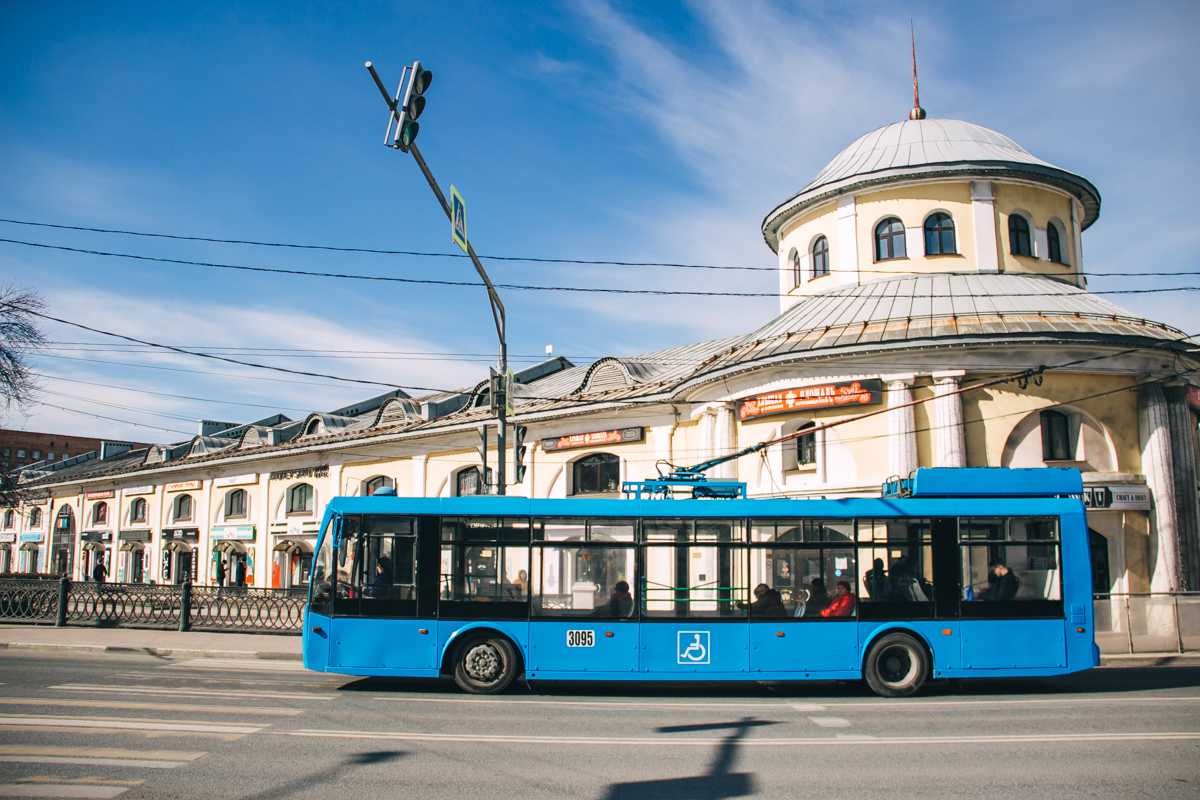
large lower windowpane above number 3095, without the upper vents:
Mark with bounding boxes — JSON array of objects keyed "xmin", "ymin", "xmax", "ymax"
[{"xmin": 533, "ymin": 543, "xmax": 637, "ymax": 619}]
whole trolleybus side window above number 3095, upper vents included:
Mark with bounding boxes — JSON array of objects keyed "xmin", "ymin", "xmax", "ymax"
[{"xmin": 533, "ymin": 518, "xmax": 637, "ymax": 619}]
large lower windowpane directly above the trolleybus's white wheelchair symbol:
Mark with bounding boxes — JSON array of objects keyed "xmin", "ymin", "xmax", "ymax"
[{"xmin": 643, "ymin": 544, "xmax": 750, "ymax": 619}]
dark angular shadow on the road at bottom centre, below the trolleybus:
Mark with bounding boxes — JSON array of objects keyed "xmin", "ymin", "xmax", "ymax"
[{"xmin": 604, "ymin": 717, "xmax": 779, "ymax": 800}]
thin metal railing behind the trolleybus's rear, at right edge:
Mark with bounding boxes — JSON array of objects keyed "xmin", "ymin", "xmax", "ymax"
[{"xmin": 1092, "ymin": 591, "xmax": 1200, "ymax": 655}]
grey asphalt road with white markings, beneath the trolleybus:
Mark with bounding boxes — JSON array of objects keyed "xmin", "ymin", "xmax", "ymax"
[{"xmin": 0, "ymin": 651, "xmax": 1200, "ymax": 800}]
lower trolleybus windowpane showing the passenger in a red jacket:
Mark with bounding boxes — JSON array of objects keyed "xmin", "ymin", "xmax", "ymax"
[{"xmin": 750, "ymin": 546, "xmax": 858, "ymax": 619}]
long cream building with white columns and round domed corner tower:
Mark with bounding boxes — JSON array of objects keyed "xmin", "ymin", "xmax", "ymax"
[{"xmin": 11, "ymin": 109, "xmax": 1200, "ymax": 623}]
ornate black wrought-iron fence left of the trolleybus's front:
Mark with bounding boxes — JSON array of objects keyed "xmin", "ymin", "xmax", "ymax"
[{"xmin": 0, "ymin": 579, "xmax": 308, "ymax": 634}]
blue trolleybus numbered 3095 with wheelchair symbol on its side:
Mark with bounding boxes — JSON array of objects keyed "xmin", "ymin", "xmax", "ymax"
[{"xmin": 304, "ymin": 469, "xmax": 1099, "ymax": 697}]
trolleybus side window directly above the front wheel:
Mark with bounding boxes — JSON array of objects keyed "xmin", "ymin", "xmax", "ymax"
[{"xmin": 440, "ymin": 517, "xmax": 529, "ymax": 614}]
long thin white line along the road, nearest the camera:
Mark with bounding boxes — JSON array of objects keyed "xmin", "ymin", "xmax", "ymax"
[{"xmin": 266, "ymin": 730, "xmax": 1200, "ymax": 747}]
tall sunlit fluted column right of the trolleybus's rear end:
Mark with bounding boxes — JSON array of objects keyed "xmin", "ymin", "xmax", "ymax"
[{"xmin": 1138, "ymin": 384, "xmax": 1180, "ymax": 591}]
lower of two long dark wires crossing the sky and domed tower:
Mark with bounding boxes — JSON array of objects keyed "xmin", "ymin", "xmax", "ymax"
[{"xmin": 0, "ymin": 239, "xmax": 1200, "ymax": 299}]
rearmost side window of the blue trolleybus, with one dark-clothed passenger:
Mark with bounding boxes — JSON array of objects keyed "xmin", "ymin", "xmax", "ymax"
[{"xmin": 959, "ymin": 517, "xmax": 1062, "ymax": 616}]
